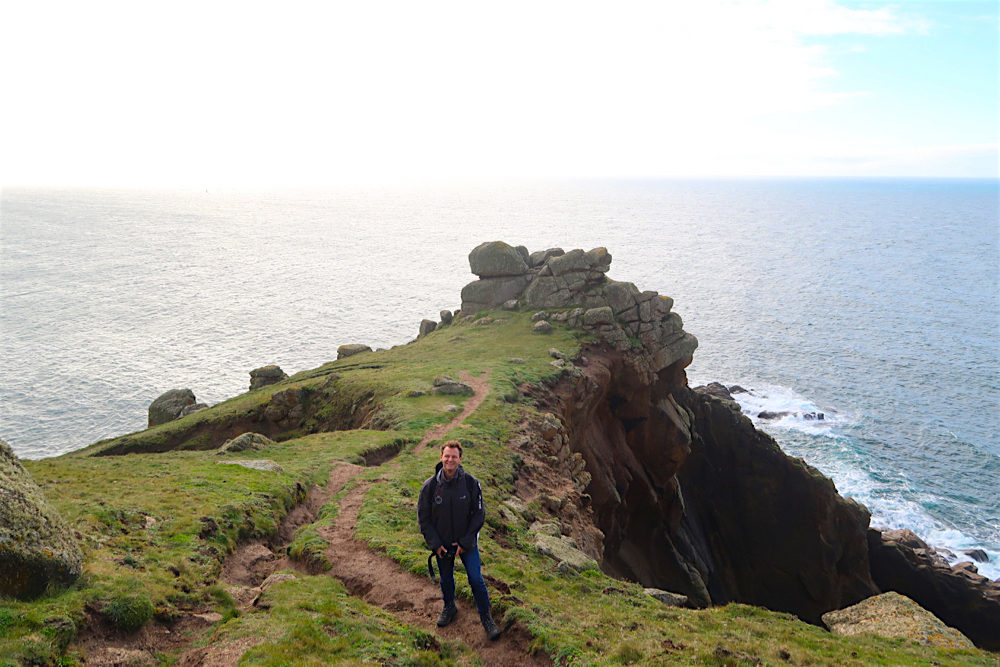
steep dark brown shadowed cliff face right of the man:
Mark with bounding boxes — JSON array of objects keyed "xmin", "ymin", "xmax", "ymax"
[{"xmin": 549, "ymin": 346, "xmax": 878, "ymax": 623}]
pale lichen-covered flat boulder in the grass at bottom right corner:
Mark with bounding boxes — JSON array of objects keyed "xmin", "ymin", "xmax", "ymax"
[{"xmin": 823, "ymin": 593, "xmax": 973, "ymax": 649}]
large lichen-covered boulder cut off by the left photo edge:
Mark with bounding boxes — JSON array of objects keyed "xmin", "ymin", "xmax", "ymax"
[{"xmin": 0, "ymin": 440, "xmax": 83, "ymax": 599}]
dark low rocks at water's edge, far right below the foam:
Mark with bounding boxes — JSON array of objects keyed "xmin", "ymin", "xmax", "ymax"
[{"xmin": 868, "ymin": 529, "xmax": 1000, "ymax": 651}]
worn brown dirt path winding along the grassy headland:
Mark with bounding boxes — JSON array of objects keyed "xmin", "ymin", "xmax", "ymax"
[{"xmin": 184, "ymin": 371, "xmax": 552, "ymax": 667}]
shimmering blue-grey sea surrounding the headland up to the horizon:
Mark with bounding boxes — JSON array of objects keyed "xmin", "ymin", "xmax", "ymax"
[{"xmin": 0, "ymin": 179, "xmax": 1000, "ymax": 578}]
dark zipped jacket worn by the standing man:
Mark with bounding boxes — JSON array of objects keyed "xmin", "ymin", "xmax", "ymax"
[{"xmin": 417, "ymin": 466, "xmax": 486, "ymax": 551}]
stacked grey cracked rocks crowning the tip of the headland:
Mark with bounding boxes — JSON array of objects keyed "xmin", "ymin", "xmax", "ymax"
[{"xmin": 461, "ymin": 241, "xmax": 698, "ymax": 372}]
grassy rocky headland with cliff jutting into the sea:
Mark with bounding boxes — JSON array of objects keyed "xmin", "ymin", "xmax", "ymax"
[{"xmin": 0, "ymin": 242, "xmax": 1000, "ymax": 665}]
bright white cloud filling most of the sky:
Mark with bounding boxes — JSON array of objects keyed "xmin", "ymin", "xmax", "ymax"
[{"xmin": 0, "ymin": 0, "xmax": 968, "ymax": 184}]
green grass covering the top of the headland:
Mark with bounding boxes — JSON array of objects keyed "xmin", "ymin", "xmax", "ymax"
[{"xmin": 0, "ymin": 313, "xmax": 996, "ymax": 665}]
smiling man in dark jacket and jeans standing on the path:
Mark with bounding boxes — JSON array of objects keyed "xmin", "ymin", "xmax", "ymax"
[{"xmin": 417, "ymin": 440, "xmax": 500, "ymax": 639}]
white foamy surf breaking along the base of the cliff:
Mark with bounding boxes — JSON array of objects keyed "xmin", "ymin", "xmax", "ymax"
[{"xmin": 727, "ymin": 383, "xmax": 1000, "ymax": 579}]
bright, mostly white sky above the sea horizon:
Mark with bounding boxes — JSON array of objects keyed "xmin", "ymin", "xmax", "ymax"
[{"xmin": 0, "ymin": 0, "xmax": 1000, "ymax": 187}]
